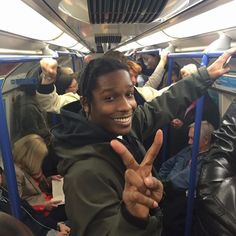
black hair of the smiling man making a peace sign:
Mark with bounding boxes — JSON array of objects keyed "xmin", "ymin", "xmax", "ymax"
[{"xmin": 79, "ymin": 57, "xmax": 129, "ymax": 102}]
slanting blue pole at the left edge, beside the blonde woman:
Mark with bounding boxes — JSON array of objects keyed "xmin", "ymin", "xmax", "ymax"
[{"xmin": 0, "ymin": 88, "xmax": 20, "ymax": 219}]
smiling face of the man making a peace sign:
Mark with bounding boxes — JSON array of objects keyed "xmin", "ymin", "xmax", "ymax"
[{"xmin": 88, "ymin": 70, "xmax": 137, "ymax": 135}]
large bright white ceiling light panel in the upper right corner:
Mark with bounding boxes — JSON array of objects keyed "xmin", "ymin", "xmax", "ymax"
[{"xmin": 163, "ymin": 1, "xmax": 236, "ymax": 38}]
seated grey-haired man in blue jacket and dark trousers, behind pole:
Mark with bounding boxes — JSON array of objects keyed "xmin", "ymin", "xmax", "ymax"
[{"xmin": 159, "ymin": 121, "xmax": 214, "ymax": 236}]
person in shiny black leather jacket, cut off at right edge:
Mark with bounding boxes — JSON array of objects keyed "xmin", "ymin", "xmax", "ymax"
[{"xmin": 194, "ymin": 99, "xmax": 236, "ymax": 236}]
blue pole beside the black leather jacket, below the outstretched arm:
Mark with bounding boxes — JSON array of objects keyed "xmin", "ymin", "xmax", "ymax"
[{"xmin": 185, "ymin": 55, "xmax": 208, "ymax": 236}]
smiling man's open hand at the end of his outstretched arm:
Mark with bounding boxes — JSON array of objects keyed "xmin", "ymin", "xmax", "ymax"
[{"xmin": 207, "ymin": 47, "xmax": 236, "ymax": 79}]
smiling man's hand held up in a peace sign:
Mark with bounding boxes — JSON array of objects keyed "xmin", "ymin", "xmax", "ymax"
[{"xmin": 111, "ymin": 130, "xmax": 163, "ymax": 218}]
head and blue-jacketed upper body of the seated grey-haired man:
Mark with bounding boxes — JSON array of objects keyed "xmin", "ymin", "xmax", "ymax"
[{"xmin": 159, "ymin": 121, "xmax": 214, "ymax": 190}]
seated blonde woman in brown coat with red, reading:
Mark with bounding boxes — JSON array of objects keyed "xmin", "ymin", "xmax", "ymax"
[{"xmin": 4, "ymin": 134, "xmax": 70, "ymax": 235}]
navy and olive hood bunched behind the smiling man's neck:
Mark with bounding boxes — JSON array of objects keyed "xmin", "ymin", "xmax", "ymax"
[{"xmin": 52, "ymin": 101, "xmax": 121, "ymax": 175}]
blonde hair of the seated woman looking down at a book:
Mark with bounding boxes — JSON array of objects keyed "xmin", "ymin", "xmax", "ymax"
[{"xmin": 13, "ymin": 134, "xmax": 48, "ymax": 176}]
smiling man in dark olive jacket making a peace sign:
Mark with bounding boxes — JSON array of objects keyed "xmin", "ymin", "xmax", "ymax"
[{"xmin": 52, "ymin": 49, "xmax": 236, "ymax": 236}]
